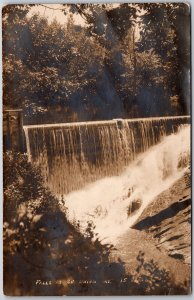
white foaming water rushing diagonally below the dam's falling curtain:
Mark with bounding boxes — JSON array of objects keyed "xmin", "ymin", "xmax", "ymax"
[{"xmin": 61, "ymin": 125, "xmax": 190, "ymax": 244}]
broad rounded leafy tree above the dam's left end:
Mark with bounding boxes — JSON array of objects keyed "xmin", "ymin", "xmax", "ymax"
[{"xmin": 4, "ymin": 10, "xmax": 105, "ymax": 120}]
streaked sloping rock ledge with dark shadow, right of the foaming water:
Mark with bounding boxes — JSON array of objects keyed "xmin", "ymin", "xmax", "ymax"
[{"xmin": 133, "ymin": 170, "xmax": 191, "ymax": 265}]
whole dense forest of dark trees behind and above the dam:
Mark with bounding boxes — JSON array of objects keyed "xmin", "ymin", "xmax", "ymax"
[{"xmin": 3, "ymin": 3, "xmax": 190, "ymax": 124}]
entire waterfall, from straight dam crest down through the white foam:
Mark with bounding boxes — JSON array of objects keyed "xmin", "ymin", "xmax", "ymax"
[{"xmin": 24, "ymin": 116, "xmax": 190, "ymax": 243}]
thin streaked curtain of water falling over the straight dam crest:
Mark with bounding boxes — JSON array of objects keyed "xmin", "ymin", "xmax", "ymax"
[{"xmin": 24, "ymin": 116, "xmax": 189, "ymax": 196}]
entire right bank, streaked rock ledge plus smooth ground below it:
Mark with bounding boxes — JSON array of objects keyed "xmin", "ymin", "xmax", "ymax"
[{"xmin": 112, "ymin": 170, "xmax": 191, "ymax": 294}]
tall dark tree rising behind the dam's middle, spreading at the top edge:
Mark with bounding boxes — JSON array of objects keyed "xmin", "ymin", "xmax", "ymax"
[{"xmin": 63, "ymin": 4, "xmax": 139, "ymax": 118}]
